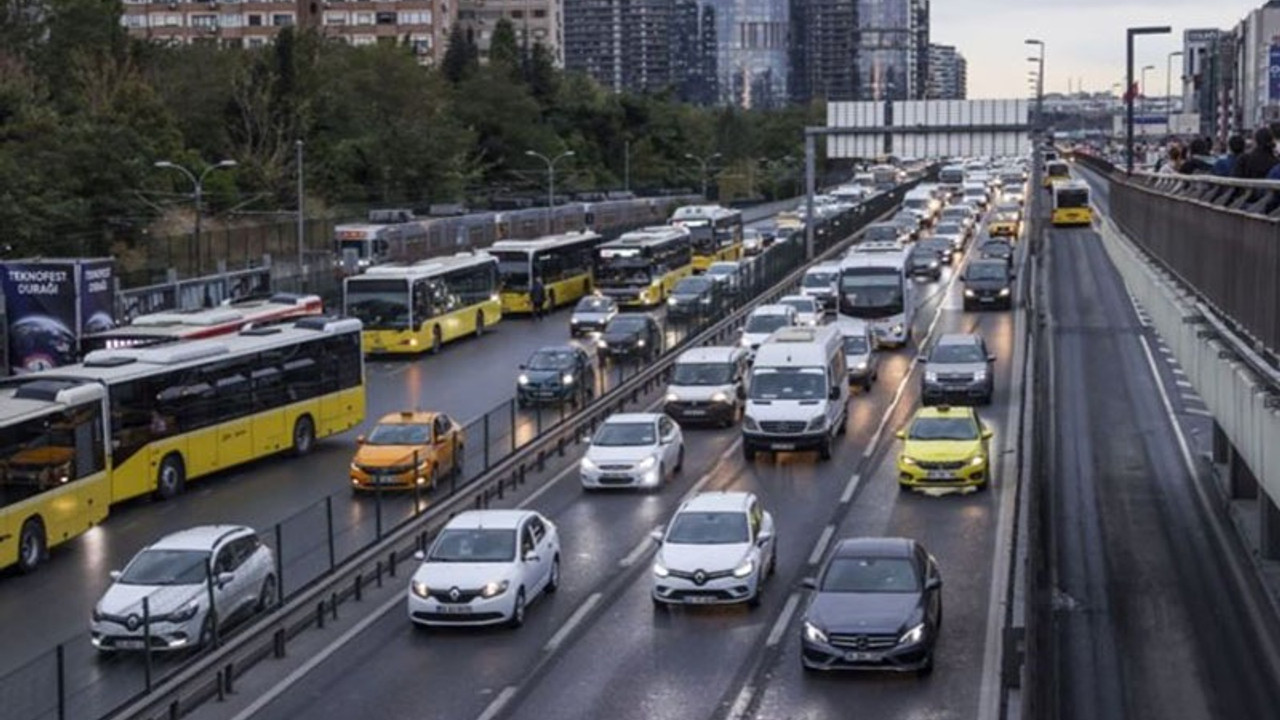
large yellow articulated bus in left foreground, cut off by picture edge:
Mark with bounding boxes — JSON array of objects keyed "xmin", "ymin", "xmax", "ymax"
[{"xmin": 0, "ymin": 316, "xmax": 365, "ymax": 571}]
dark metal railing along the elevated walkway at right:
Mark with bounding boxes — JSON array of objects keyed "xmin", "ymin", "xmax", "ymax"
[{"xmin": 1075, "ymin": 148, "xmax": 1280, "ymax": 372}]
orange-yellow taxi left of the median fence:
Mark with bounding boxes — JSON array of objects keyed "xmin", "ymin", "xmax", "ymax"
[{"xmin": 351, "ymin": 410, "xmax": 466, "ymax": 491}]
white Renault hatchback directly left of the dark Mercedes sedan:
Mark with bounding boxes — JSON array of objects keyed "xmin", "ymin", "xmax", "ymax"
[{"xmin": 653, "ymin": 492, "xmax": 777, "ymax": 607}]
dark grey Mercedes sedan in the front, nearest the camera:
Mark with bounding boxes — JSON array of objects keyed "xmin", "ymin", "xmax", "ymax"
[{"xmin": 800, "ymin": 538, "xmax": 942, "ymax": 675}]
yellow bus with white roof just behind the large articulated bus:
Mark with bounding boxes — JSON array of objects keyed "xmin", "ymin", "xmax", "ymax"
[{"xmin": 342, "ymin": 252, "xmax": 502, "ymax": 355}]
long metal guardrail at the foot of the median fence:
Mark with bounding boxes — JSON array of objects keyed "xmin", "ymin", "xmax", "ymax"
[{"xmin": 97, "ymin": 179, "xmax": 919, "ymax": 719}]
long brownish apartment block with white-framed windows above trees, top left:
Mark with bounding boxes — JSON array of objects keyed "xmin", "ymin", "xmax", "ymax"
[{"xmin": 120, "ymin": 0, "xmax": 457, "ymax": 64}]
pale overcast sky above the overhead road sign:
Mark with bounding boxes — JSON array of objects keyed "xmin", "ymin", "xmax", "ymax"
[{"xmin": 929, "ymin": 0, "xmax": 1265, "ymax": 97}]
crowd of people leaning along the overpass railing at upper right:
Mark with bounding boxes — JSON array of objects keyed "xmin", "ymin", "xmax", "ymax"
[{"xmin": 1155, "ymin": 122, "xmax": 1280, "ymax": 181}]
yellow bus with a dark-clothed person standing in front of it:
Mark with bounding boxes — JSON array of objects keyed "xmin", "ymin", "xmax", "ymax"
[{"xmin": 485, "ymin": 231, "xmax": 604, "ymax": 314}]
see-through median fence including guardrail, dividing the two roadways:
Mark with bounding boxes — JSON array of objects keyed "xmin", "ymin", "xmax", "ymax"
[{"xmin": 0, "ymin": 178, "xmax": 914, "ymax": 720}]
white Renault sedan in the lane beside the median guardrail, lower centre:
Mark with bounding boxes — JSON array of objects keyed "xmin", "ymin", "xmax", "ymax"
[{"xmin": 408, "ymin": 510, "xmax": 561, "ymax": 628}]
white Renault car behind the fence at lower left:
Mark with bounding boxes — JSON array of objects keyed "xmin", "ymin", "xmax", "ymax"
[{"xmin": 91, "ymin": 525, "xmax": 279, "ymax": 651}]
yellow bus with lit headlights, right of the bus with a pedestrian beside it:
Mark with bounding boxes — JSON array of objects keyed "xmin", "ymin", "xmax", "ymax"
[{"xmin": 595, "ymin": 225, "xmax": 694, "ymax": 307}]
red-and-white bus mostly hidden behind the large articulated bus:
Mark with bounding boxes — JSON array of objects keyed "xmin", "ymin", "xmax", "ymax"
[{"xmin": 81, "ymin": 292, "xmax": 324, "ymax": 354}]
